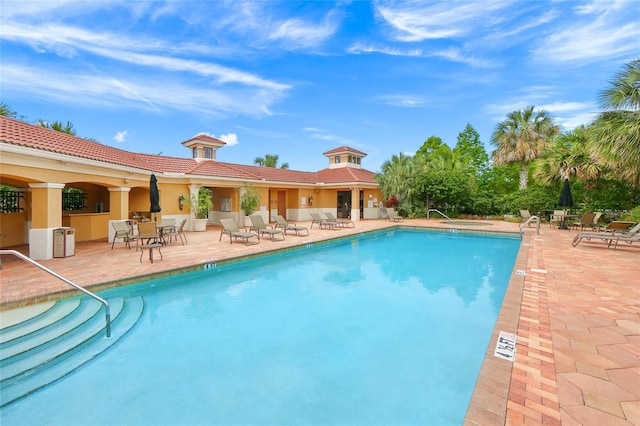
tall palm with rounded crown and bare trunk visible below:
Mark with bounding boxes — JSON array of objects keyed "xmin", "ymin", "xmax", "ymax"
[{"xmin": 491, "ymin": 105, "xmax": 560, "ymax": 189}]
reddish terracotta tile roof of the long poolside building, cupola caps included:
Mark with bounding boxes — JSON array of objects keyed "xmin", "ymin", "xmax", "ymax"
[{"xmin": 0, "ymin": 117, "xmax": 376, "ymax": 184}]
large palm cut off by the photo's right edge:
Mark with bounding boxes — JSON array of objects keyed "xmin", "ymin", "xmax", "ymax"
[{"xmin": 589, "ymin": 58, "xmax": 640, "ymax": 186}]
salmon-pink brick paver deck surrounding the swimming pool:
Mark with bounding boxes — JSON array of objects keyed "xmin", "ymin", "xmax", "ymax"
[{"xmin": 0, "ymin": 219, "xmax": 640, "ymax": 426}]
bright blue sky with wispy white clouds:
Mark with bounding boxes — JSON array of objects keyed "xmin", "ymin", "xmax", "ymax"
[{"xmin": 0, "ymin": 0, "xmax": 640, "ymax": 171}]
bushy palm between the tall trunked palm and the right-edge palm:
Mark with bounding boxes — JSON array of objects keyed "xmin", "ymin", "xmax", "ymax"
[{"xmin": 534, "ymin": 126, "xmax": 604, "ymax": 185}]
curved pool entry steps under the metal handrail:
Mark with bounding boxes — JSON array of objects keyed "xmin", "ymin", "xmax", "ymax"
[{"xmin": 0, "ymin": 297, "xmax": 144, "ymax": 407}]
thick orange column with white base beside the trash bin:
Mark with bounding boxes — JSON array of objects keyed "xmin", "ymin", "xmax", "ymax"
[{"xmin": 29, "ymin": 183, "xmax": 64, "ymax": 260}]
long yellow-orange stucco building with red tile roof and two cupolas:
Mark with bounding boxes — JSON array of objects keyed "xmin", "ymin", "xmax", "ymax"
[{"xmin": 0, "ymin": 117, "xmax": 382, "ymax": 259}]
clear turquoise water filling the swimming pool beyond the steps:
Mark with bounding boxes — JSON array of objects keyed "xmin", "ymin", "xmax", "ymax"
[{"xmin": 0, "ymin": 230, "xmax": 520, "ymax": 426}]
